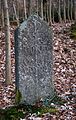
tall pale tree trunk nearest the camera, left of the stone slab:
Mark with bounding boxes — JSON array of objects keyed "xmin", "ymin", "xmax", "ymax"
[{"xmin": 3, "ymin": 0, "xmax": 12, "ymax": 85}]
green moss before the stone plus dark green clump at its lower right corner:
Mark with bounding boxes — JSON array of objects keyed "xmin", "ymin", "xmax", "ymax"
[{"xmin": 0, "ymin": 95, "xmax": 66, "ymax": 120}]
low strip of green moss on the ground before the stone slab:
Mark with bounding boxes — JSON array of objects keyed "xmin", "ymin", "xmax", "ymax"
[{"xmin": 0, "ymin": 104, "xmax": 58, "ymax": 120}]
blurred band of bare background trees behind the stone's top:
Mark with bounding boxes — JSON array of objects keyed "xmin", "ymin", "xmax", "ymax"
[{"xmin": 0, "ymin": 0, "xmax": 76, "ymax": 26}]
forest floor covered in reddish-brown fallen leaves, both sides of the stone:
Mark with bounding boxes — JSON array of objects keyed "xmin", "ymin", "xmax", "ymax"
[{"xmin": 0, "ymin": 23, "xmax": 76, "ymax": 120}]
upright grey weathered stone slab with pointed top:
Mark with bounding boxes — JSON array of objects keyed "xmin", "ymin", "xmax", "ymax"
[{"xmin": 15, "ymin": 15, "xmax": 54, "ymax": 104}]
